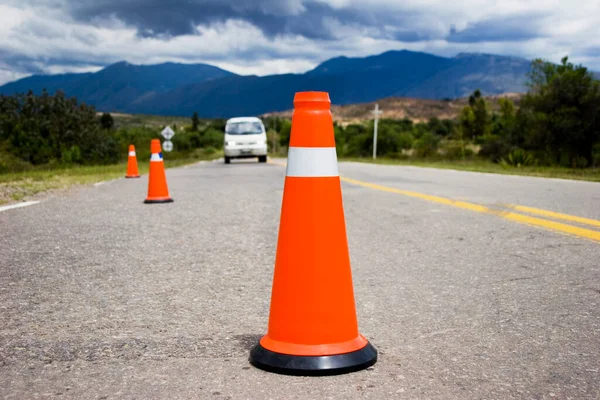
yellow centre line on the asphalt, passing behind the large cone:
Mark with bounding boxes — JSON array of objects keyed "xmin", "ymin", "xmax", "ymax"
[{"xmin": 270, "ymin": 161, "xmax": 600, "ymax": 242}]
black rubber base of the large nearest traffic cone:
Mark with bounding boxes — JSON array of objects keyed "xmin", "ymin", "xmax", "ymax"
[{"xmin": 250, "ymin": 343, "xmax": 377, "ymax": 376}]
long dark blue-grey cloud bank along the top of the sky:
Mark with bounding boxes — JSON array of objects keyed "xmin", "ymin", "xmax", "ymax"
[{"xmin": 9, "ymin": 0, "xmax": 538, "ymax": 43}]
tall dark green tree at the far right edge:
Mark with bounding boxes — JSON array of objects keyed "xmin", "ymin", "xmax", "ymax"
[{"xmin": 517, "ymin": 57, "xmax": 600, "ymax": 167}]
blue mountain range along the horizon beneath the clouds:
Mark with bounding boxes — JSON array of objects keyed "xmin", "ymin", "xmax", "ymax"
[{"xmin": 0, "ymin": 50, "xmax": 530, "ymax": 118}]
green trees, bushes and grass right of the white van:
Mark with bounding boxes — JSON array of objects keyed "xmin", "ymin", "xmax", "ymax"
[{"xmin": 265, "ymin": 57, "xmax": 600, "ymax": 173}]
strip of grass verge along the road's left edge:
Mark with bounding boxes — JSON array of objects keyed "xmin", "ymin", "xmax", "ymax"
[{"xmin": 0, "ymin": 152, "xmax": 222, "ymax": 205}]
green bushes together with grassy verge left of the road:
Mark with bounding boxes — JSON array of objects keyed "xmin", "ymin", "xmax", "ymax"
[{"xmin": 0, "ymin": 92, "xmax": 223, "ymax": 204}]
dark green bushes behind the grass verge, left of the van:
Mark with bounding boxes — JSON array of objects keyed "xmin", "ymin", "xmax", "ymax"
[{"xmin": 0, "ymin": 91, "xmax": 223, "ymax": 173}]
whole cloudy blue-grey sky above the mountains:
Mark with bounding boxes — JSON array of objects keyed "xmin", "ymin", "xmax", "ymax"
[{"xmin": 0, "ymin": 0, "xmax": 600, "ymax": 84}]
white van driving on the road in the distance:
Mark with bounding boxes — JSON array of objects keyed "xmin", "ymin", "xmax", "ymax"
[{"xmin": 223, "ymin": 117, "xmax": 267, "ymax": 164}]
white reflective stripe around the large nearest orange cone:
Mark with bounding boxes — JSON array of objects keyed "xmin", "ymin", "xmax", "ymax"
[{"xmin": 286, "ymin": 147, "xmax": 340, "ymax": 177}]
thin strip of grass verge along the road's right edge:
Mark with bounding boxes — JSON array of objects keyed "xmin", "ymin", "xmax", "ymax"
[{"xmin": 340, "ymin": 157, "xmax": 600, "ymax": 182}]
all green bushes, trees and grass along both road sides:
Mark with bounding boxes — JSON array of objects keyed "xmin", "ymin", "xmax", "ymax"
[{"xmin": 0, "ymin": 57, "xmax": 600, "ymax": 202}]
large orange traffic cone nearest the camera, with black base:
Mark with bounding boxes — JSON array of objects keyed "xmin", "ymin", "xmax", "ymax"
[{"xmin": 250, "ymin": 92, "xmax": 377, "ymax": 375}]
